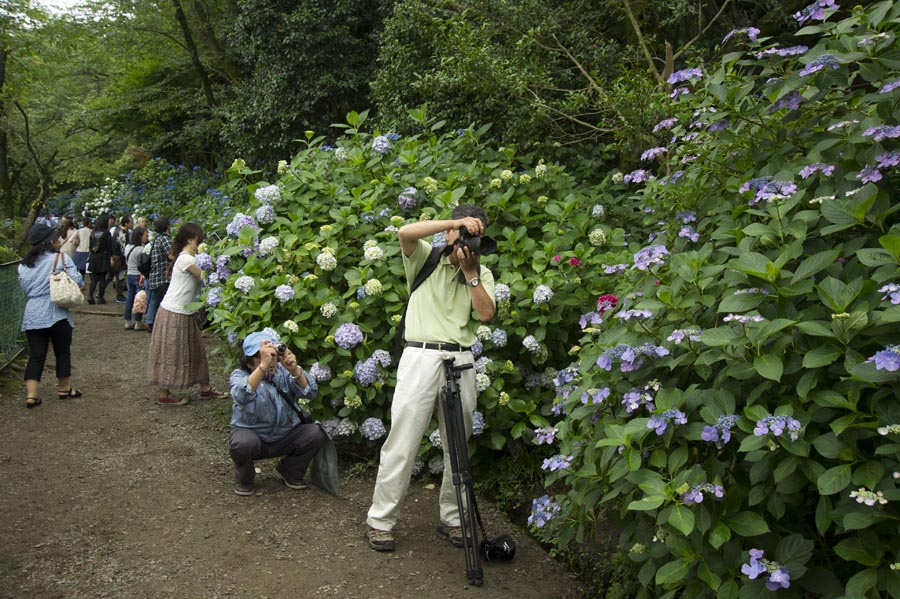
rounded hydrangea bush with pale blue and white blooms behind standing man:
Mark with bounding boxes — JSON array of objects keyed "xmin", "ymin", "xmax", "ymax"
[{"xmin": 198, "ymin": 110, "xmax": 630, "ymax": 464}]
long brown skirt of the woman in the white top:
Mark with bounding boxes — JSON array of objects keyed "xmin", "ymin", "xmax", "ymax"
[{"xmin": 147, "ymin": 307, "xmax": 209, "ymax": 389}]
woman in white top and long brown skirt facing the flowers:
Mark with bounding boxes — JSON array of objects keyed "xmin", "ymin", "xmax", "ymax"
[{"xmin": 147, "ymin": 223, "xmax": 227, "ymax": 406}]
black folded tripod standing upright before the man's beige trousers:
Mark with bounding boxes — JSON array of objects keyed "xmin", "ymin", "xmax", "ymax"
[{"xmin": 441, "ymin": 358, "xmax": 484, "ymax": 587}]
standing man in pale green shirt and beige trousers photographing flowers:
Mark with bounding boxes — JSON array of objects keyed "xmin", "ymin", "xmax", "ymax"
[{"xmin": 366, "ymin": 205, "xmax": 495, "ymax": 551}]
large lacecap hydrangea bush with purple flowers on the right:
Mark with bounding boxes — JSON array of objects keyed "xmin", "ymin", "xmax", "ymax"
[{"xmin": 531, "ymin": 0, "xmax": 900, "ymax": 598}]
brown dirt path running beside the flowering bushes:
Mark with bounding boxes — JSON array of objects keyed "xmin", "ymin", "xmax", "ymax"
[{"xmin": 0, "ymin": 304, "xmax": 577, "ymax": 599}]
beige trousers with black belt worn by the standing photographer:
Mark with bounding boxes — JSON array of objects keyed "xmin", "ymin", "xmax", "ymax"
[{"xmin": 366, "ymin": 347, "xmax": 476, "ymax": 530}]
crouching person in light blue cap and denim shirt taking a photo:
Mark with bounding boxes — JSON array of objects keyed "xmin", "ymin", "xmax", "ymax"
[{"xmin": 229, "ymin": 331, "xmax": 325, "ymax": 495}]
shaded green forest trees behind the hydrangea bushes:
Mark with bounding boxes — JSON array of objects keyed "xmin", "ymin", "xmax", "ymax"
[{"xmin": 0, "ymin": 0, "xmax": 804, "ymax": 218}]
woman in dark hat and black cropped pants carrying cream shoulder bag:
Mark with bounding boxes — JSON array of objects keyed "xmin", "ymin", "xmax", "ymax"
[{"xmin": 19, "ymin": 224, "xmax": 84, "ymax": 408}]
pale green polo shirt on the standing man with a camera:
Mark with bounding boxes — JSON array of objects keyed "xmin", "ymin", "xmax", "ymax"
[{"xmin": 401, "ymin": 239, "xmax": 494, "ymax": 347}]
